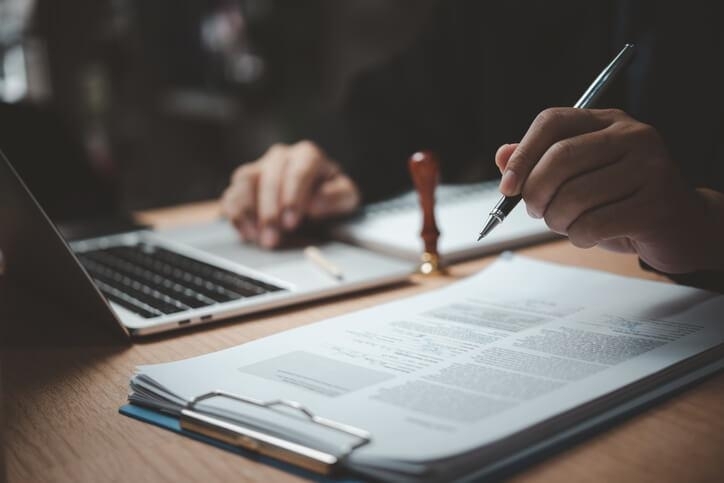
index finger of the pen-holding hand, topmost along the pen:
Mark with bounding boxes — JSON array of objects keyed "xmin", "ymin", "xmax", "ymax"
[{"xmin": 500, "ymin": 107, "xmax": 611, "ymax": 196}]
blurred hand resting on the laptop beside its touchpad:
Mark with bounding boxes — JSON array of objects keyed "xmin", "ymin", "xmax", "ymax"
[{"xmin": 221, "ymin": 141, "xmax": 360, "ymax": 248}]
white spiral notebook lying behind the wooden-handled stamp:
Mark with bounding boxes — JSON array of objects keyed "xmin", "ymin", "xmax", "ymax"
[{"xmin": 332, "ymin": 181, "xmax": 559, "ymax": 263}]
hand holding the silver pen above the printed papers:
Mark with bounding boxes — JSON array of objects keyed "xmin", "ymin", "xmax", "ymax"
[{"xmin": 495, "ymin": 108, "xmax": 724, "ymax": 273}]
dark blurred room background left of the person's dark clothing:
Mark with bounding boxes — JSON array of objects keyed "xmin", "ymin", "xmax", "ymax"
[{"xmin": 0, "ymin": 0, "xmax": 433, "ymax": 217}]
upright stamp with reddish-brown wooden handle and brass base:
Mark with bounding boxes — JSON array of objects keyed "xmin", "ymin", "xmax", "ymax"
[{"xmin": 408, "ymin": 151, "xmax": 442, "ymax": 275}]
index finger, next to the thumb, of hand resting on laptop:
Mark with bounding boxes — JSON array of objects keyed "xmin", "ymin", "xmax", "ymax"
[{"xmin": 281, "ymin": 142, "xmax": 338, "ymax": 230}]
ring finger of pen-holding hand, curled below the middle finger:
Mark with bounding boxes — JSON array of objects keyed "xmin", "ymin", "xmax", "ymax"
[{"xmin": 544, "ymin": 160, "xmax": 644, "ymax": 234}]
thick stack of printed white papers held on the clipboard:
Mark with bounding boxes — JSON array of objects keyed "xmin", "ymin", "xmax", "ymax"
[{"xmin": 130, "ymin": 256, "xmax": 724, "ymax": 481}]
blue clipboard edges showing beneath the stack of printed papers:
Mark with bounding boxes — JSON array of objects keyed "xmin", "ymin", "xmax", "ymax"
[{"xmin": 118, "ymin": 359, "xmax": 724, "ymax": 483}]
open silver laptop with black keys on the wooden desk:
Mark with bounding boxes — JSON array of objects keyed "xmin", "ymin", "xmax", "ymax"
[{"xmin": 0, "ymin": 151, "xmax": 413, "ymax": 337}]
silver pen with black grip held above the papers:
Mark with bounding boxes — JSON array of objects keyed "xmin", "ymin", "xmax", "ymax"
[{"xmin": 478, "ymin": 44, "xmax": 634, "ymax": 241}]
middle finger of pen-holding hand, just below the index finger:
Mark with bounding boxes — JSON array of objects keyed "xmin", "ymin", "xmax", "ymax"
[{"xmin": 522, "ymin": 126, "xmax": 626, "ymax": 218}]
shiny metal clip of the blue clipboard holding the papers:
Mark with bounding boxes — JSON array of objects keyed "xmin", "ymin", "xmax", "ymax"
[{"xmin": 179, "ymin": 390, "xmax": 372, "ymax": 475}]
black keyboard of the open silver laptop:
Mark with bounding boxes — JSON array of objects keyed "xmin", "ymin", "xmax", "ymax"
[{"xmin": 77, "ymin": 243, "xmax": 284, "ymax": 318}]
